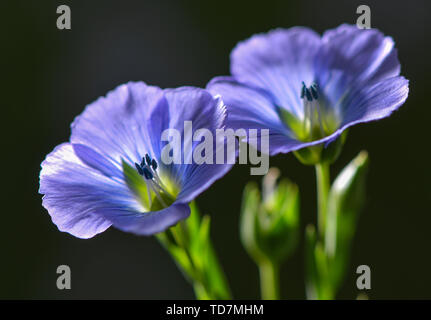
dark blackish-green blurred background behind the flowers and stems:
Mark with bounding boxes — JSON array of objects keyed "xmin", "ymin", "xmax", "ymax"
[{"xmin": 0, "ymin": 0, "xmax": 431, "ymax": 299}]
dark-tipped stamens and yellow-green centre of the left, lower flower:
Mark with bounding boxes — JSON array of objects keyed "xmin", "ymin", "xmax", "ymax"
[{"xmin": 135, "ymin": 153, "xmax": 175, "ymax": 208}]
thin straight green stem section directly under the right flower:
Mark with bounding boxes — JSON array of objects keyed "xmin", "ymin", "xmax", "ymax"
[{"xmin": 316, "ymin": 163, "xmax": 331, "ymax": 240}]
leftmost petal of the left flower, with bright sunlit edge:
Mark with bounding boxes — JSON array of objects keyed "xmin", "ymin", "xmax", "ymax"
[{"xmin": 39, "ymin": 143, "xmax": 137, "ymax": 238}]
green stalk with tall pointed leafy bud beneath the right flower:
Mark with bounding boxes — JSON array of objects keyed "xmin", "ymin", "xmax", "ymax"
[{"xmin": 305, "ymin": 151, "xmax": 368, "ymax": 300}]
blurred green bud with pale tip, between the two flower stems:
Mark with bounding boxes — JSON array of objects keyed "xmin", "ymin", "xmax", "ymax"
[{"xmin": 240, "ymin": 168, "xmax": 299, "ymax": 263}]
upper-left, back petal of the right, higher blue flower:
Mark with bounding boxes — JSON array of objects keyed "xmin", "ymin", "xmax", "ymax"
[{"xmin": 231, "ymin": 27, "xmax": 321, "ymax": 116}]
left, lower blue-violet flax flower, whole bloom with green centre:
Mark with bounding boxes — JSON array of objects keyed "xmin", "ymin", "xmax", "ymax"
[{"xmin": 39, "ymin": 82, "xmax": 231, "ymax": 238}]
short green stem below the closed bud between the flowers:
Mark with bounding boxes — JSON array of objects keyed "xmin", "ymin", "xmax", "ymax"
[{"xmin": 259, "ymin": 260, "xmax": 280, "ymax": 300}]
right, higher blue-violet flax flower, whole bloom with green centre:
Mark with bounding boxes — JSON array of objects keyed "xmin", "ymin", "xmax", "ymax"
[{"xmin": 207, "ymin": 25, "xmax": 408, "ymax": 160}]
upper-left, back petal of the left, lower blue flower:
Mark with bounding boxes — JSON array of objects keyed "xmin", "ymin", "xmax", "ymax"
[{"xmin": 70, "ymin": 82, "xmax": 162, "ymax": 167}]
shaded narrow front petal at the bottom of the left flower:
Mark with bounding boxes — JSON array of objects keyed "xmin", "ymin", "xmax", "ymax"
[{"xmin": 103, "ymin": 203, "xmax": 190, "ymax": 235}]
